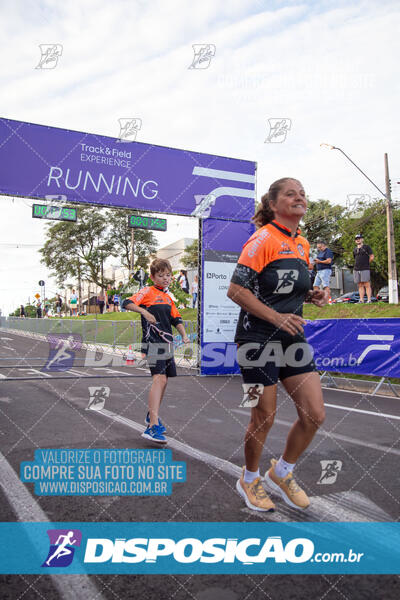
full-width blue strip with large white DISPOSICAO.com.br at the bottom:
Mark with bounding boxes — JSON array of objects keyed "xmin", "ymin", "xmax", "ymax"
[{"xmin": 0, "ymin": 522, "xmax": 400, "ymax": 575}]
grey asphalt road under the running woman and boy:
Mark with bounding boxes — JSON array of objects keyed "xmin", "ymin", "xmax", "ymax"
[{"xmin": 0, "ymin": 330, "xmax": 400, "ymax": 600}]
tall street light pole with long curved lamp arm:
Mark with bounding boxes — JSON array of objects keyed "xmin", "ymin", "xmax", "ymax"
[{"xmin": 320, "ymin": 144, "xmax": 399, "ymax": 304}]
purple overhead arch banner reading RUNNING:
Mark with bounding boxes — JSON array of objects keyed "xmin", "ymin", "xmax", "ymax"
[{"xmin": 0, "ymin": 119, "xmax": 256, "ymax": 221}]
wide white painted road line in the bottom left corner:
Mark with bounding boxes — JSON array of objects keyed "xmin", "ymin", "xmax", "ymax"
[{"xmin": 0, "ymin": 452, "xmax": 104, "ymax": 600}]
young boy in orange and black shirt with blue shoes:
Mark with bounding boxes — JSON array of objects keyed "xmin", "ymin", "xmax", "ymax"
[{"xmin": 122, "ymin": 258, "xmax": 189, "ymax": 444}]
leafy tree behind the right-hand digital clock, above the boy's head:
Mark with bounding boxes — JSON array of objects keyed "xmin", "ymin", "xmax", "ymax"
[{"xmin": 107, "ymin": 209, "xmax": 158, "ymax": 271}]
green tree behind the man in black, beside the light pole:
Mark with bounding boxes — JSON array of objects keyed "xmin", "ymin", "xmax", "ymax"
[{"xmin": 339, "ymin": 199, "xmax": 400, "ymax": 291}]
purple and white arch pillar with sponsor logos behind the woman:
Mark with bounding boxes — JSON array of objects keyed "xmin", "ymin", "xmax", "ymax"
[{"xmin": 201, "ymin": 219, "xmax": 254, "ymax": 375}]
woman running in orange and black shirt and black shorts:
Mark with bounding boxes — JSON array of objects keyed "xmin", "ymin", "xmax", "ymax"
[{"xmin": 228, "ymin": 177, "xmax": 328, "ymax": 511}]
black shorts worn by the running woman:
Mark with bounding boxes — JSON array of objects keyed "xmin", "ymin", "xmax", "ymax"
[{"xmin": 238, "ymin": 334, "xmax": 316, "ymax": 387}]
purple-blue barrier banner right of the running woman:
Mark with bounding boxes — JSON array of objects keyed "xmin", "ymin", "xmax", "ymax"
[{"xmin": 304, "ymin": 319, "xmax": 400, "ymax": 377}]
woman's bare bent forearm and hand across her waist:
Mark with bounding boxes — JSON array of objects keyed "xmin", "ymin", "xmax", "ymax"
[{"xmin": 227, "ymin": 283, "xmax": 307, "ymax": 335}]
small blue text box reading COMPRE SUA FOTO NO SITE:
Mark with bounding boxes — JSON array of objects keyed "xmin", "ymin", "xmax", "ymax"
[{"xmin": 20, "ymin": 448, "xmax": 186, "ymax": 496}]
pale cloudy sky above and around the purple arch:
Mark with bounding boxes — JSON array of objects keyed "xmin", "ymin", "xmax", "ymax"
[{"xmin": 0, "ymin": 0, "xmax": 400, "ymax": 314}]
